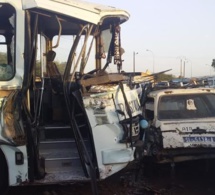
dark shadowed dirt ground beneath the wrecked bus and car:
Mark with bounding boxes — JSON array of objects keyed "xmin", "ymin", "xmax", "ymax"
[{"xmin": 6, "ymin": 160, "xmax": 215, "ymax": 195}]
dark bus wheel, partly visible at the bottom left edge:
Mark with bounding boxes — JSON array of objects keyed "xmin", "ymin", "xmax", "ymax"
[{"xmin": 0, "ymin": 150, "xmax": 8, "ymax": 194}]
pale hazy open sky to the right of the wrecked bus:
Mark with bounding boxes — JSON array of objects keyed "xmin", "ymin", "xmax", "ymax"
[{"xmin": 87, "ymin": 0, "xmax": 215, "ymax": 77}]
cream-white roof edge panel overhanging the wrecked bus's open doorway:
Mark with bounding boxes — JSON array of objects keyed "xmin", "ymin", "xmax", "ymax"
[{"xmin": 22, "ymin": 0, "xmax": 129, "ymax": 24}]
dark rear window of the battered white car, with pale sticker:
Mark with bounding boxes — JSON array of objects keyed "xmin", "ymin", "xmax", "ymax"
[{"xmin": 158, "ymin": 94, "xmax": 215, "ymax": 120}]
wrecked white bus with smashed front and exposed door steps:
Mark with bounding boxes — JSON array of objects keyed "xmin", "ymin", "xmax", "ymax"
[{"xmin": 0, "ymin": 0, "xmax": 145, "ymax": 194}]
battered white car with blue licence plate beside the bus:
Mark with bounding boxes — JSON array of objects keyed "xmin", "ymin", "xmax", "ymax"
[{"xmin": 142, "ymin": 88, "xmax": 215, "ymax": 163}]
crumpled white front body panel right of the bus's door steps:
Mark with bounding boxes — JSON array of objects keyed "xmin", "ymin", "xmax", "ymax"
[{"xmin": 84, "ymin": 86, "xmax": 141, "ymax": 179}]
